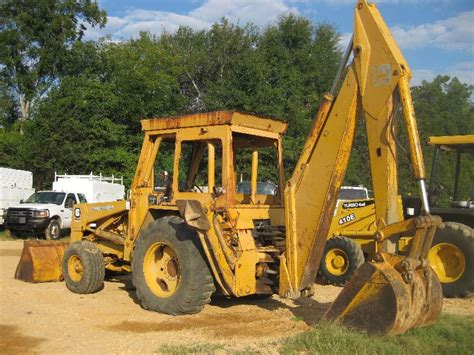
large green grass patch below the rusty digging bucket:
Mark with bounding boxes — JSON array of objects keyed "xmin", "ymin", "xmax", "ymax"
[{"xmin": 280, "ymin": 314, "xmax": 474, "ymax": 354}]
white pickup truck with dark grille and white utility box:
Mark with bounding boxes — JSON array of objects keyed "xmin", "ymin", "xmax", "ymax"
[{"xmin": 5, "ymin": 173, "xmax": 125, "ymax": 240}]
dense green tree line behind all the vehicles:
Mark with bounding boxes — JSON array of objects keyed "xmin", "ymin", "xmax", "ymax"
[{"xmin": 0, "ymin": 4, "xmax": 474, "ymax": 200}]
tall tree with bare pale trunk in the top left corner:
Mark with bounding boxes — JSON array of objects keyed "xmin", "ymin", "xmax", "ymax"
[{"xmin": 0, "ymin": 0, "xmax": 106, "ymax": 125}]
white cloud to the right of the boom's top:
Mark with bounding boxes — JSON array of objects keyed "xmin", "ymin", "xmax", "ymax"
[{"xmin": 391, "ymin": 11, "xmax": 474, "ymax": 54}]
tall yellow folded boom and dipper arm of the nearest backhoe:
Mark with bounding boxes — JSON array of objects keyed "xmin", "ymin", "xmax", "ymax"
[{"xmin": 280, "ymin": 0, "xmax": 440, "ymax": 334}]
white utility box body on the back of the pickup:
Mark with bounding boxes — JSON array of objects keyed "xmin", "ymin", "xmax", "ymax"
[{"xmin": 53, "ymin": 173, "xmax": 125, "ymax": 203}]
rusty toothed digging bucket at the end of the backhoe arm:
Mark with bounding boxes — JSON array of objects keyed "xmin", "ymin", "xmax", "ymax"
[{"xmin": 326, "ymin": 256, "xmax": 443, "ymax": 334}]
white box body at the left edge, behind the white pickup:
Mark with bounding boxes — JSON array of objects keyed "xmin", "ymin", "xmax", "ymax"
[{"xmin": 0, "ymin": 168, "xmax": 35, "ymax": 225}]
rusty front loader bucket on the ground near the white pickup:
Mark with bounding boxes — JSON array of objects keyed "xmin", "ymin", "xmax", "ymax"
[{"xmin": 15, "ymin": 240, "xmax": 69, "ymax": 282}]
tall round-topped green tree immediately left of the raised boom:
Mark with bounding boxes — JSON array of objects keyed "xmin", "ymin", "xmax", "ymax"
[{"xmin": 259, "ymin": 14, "xmax": 341, "ymax": 176}]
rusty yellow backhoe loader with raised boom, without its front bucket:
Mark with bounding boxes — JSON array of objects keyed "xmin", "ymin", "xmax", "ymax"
[{"xmin": 15, "ymin": 0, "xmax": 442, "ymax": 334}]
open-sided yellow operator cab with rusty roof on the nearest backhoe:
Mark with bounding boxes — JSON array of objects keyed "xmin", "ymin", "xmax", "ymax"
[{"xmin": 137, "ymin": 111, "xmax": 287, "ymax": 206}]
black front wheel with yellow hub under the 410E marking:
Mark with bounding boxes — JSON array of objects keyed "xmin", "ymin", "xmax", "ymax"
[{"xmin": 319, "ymin": 237, "xmax": 365, "ymax": 286}]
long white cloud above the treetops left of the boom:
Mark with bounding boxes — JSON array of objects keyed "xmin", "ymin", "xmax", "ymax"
[{"xmin": 86, "ymin": 0, "xmax": 298, "ymax": 40}]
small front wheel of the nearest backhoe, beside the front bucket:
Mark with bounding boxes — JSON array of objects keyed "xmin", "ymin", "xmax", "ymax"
[{"xmin": 63, "ymin": 240, "xmax": 105, "ymax": 293}]
